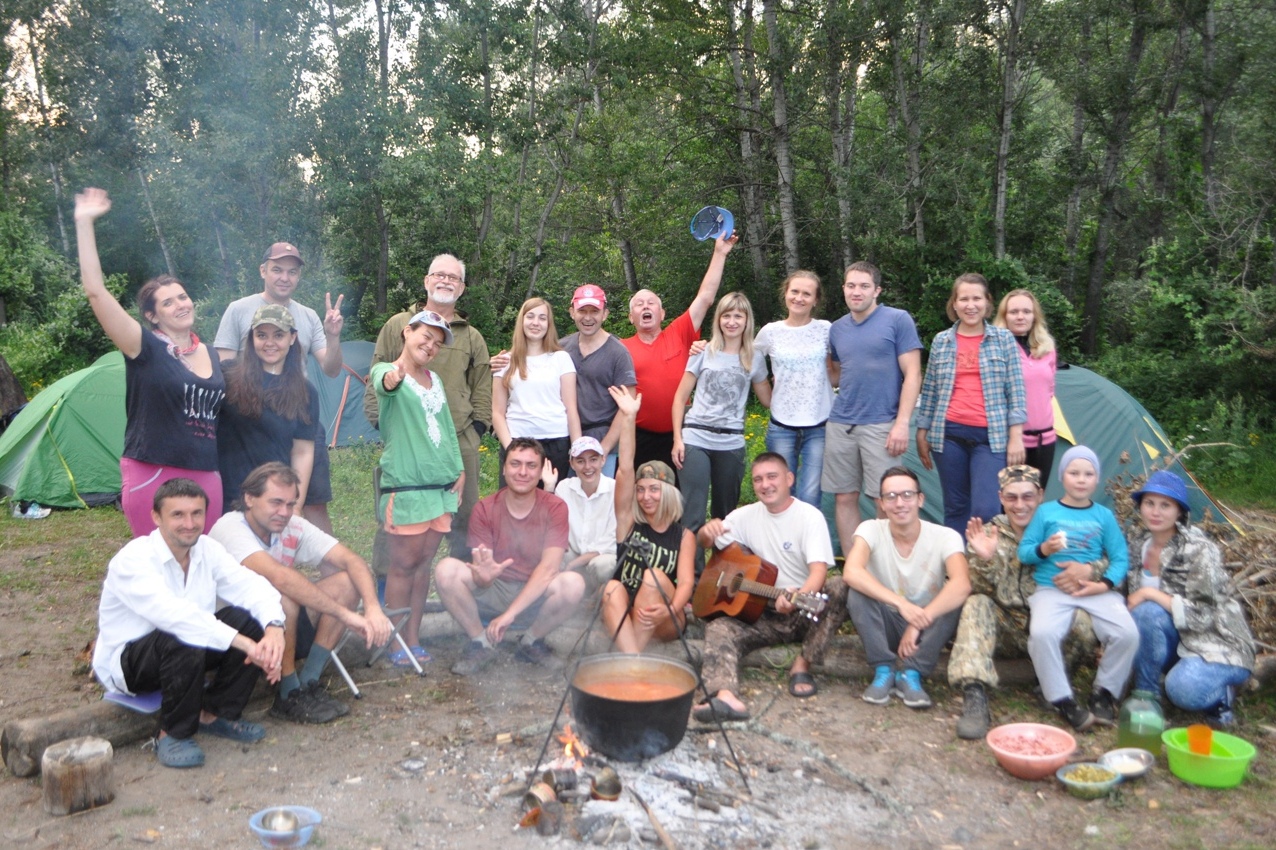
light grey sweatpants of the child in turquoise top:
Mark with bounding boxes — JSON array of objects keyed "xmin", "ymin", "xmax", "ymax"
[{"xmin": 1028, "ymin": 587, "xmax": 1138, "ymax": 702}]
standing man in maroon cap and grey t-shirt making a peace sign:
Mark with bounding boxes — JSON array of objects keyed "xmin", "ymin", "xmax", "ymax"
[{"xmin": 213, "ymin": 242, "xmax": 346, "ymax": 533}]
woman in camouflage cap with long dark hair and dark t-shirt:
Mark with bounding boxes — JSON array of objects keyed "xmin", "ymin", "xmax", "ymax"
[{"xmin": 217, "ymin": 304, "xmax": 319, "ymax": 513}]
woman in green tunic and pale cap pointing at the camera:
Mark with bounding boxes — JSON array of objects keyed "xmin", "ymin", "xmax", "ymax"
[{"xmin": 369, "ymin": 310, "xmax": 466, "ymax": 667}]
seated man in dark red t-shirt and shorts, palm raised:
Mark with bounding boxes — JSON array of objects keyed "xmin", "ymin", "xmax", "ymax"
[{"xmin": 434, "ymin": 438, "xmax": 584, "ymax": 676}]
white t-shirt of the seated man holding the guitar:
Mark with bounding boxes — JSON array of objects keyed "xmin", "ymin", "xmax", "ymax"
[{"xmin": 713, "ymin": 499, "xmax": 833, "ymax": 587}]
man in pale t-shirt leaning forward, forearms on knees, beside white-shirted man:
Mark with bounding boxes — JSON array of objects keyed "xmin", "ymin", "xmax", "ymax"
[{"xmin": 208, "ymin": 463, "xmax": 393, "ymax": 724}]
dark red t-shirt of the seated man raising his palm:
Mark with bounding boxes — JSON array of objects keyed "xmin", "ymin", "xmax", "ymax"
[{"xmin": 470, "ymin": 488, "xmax": 567, "ymax": 582}]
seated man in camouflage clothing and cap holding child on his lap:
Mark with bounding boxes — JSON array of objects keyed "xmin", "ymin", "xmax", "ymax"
[{"xmin": 948, "ymin": 465, "xmax": 1108, "ymax": 740}]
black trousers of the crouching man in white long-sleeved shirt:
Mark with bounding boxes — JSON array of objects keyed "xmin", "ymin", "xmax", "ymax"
[{"xmin": 120, "ymin": 605, "xmax": 264, "ymax": 738}]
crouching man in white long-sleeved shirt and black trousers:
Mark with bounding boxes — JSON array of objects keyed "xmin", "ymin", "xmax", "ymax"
[{"xmin": 93, "ymin": 479, "xmax": 283, "ymax": 767}]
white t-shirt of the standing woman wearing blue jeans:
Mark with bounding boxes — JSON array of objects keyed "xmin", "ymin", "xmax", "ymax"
[{"xmin": 753, "ymin": 319, "xmax": 833, "ymax": 428}]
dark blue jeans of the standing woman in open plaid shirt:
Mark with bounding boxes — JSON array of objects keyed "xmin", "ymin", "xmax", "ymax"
[{"xmin": 930, "ymin": 422, "xmax": 1005, "ymax": 539}]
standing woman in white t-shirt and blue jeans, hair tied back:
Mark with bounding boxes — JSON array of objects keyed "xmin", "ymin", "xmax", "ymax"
[{"xmin": 753, "ymin": 271, "xmax": 833, "ymax": 508}]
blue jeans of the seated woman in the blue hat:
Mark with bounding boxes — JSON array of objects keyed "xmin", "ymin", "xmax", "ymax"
[{"xmin": 1132, "ymin": 602, "xmax": 1249, "ymax": 711}]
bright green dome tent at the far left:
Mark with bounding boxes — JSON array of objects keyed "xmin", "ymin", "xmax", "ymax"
[{"xmin": 0, "ymin": 351, "xmax": 124, "ymax": 508}]
